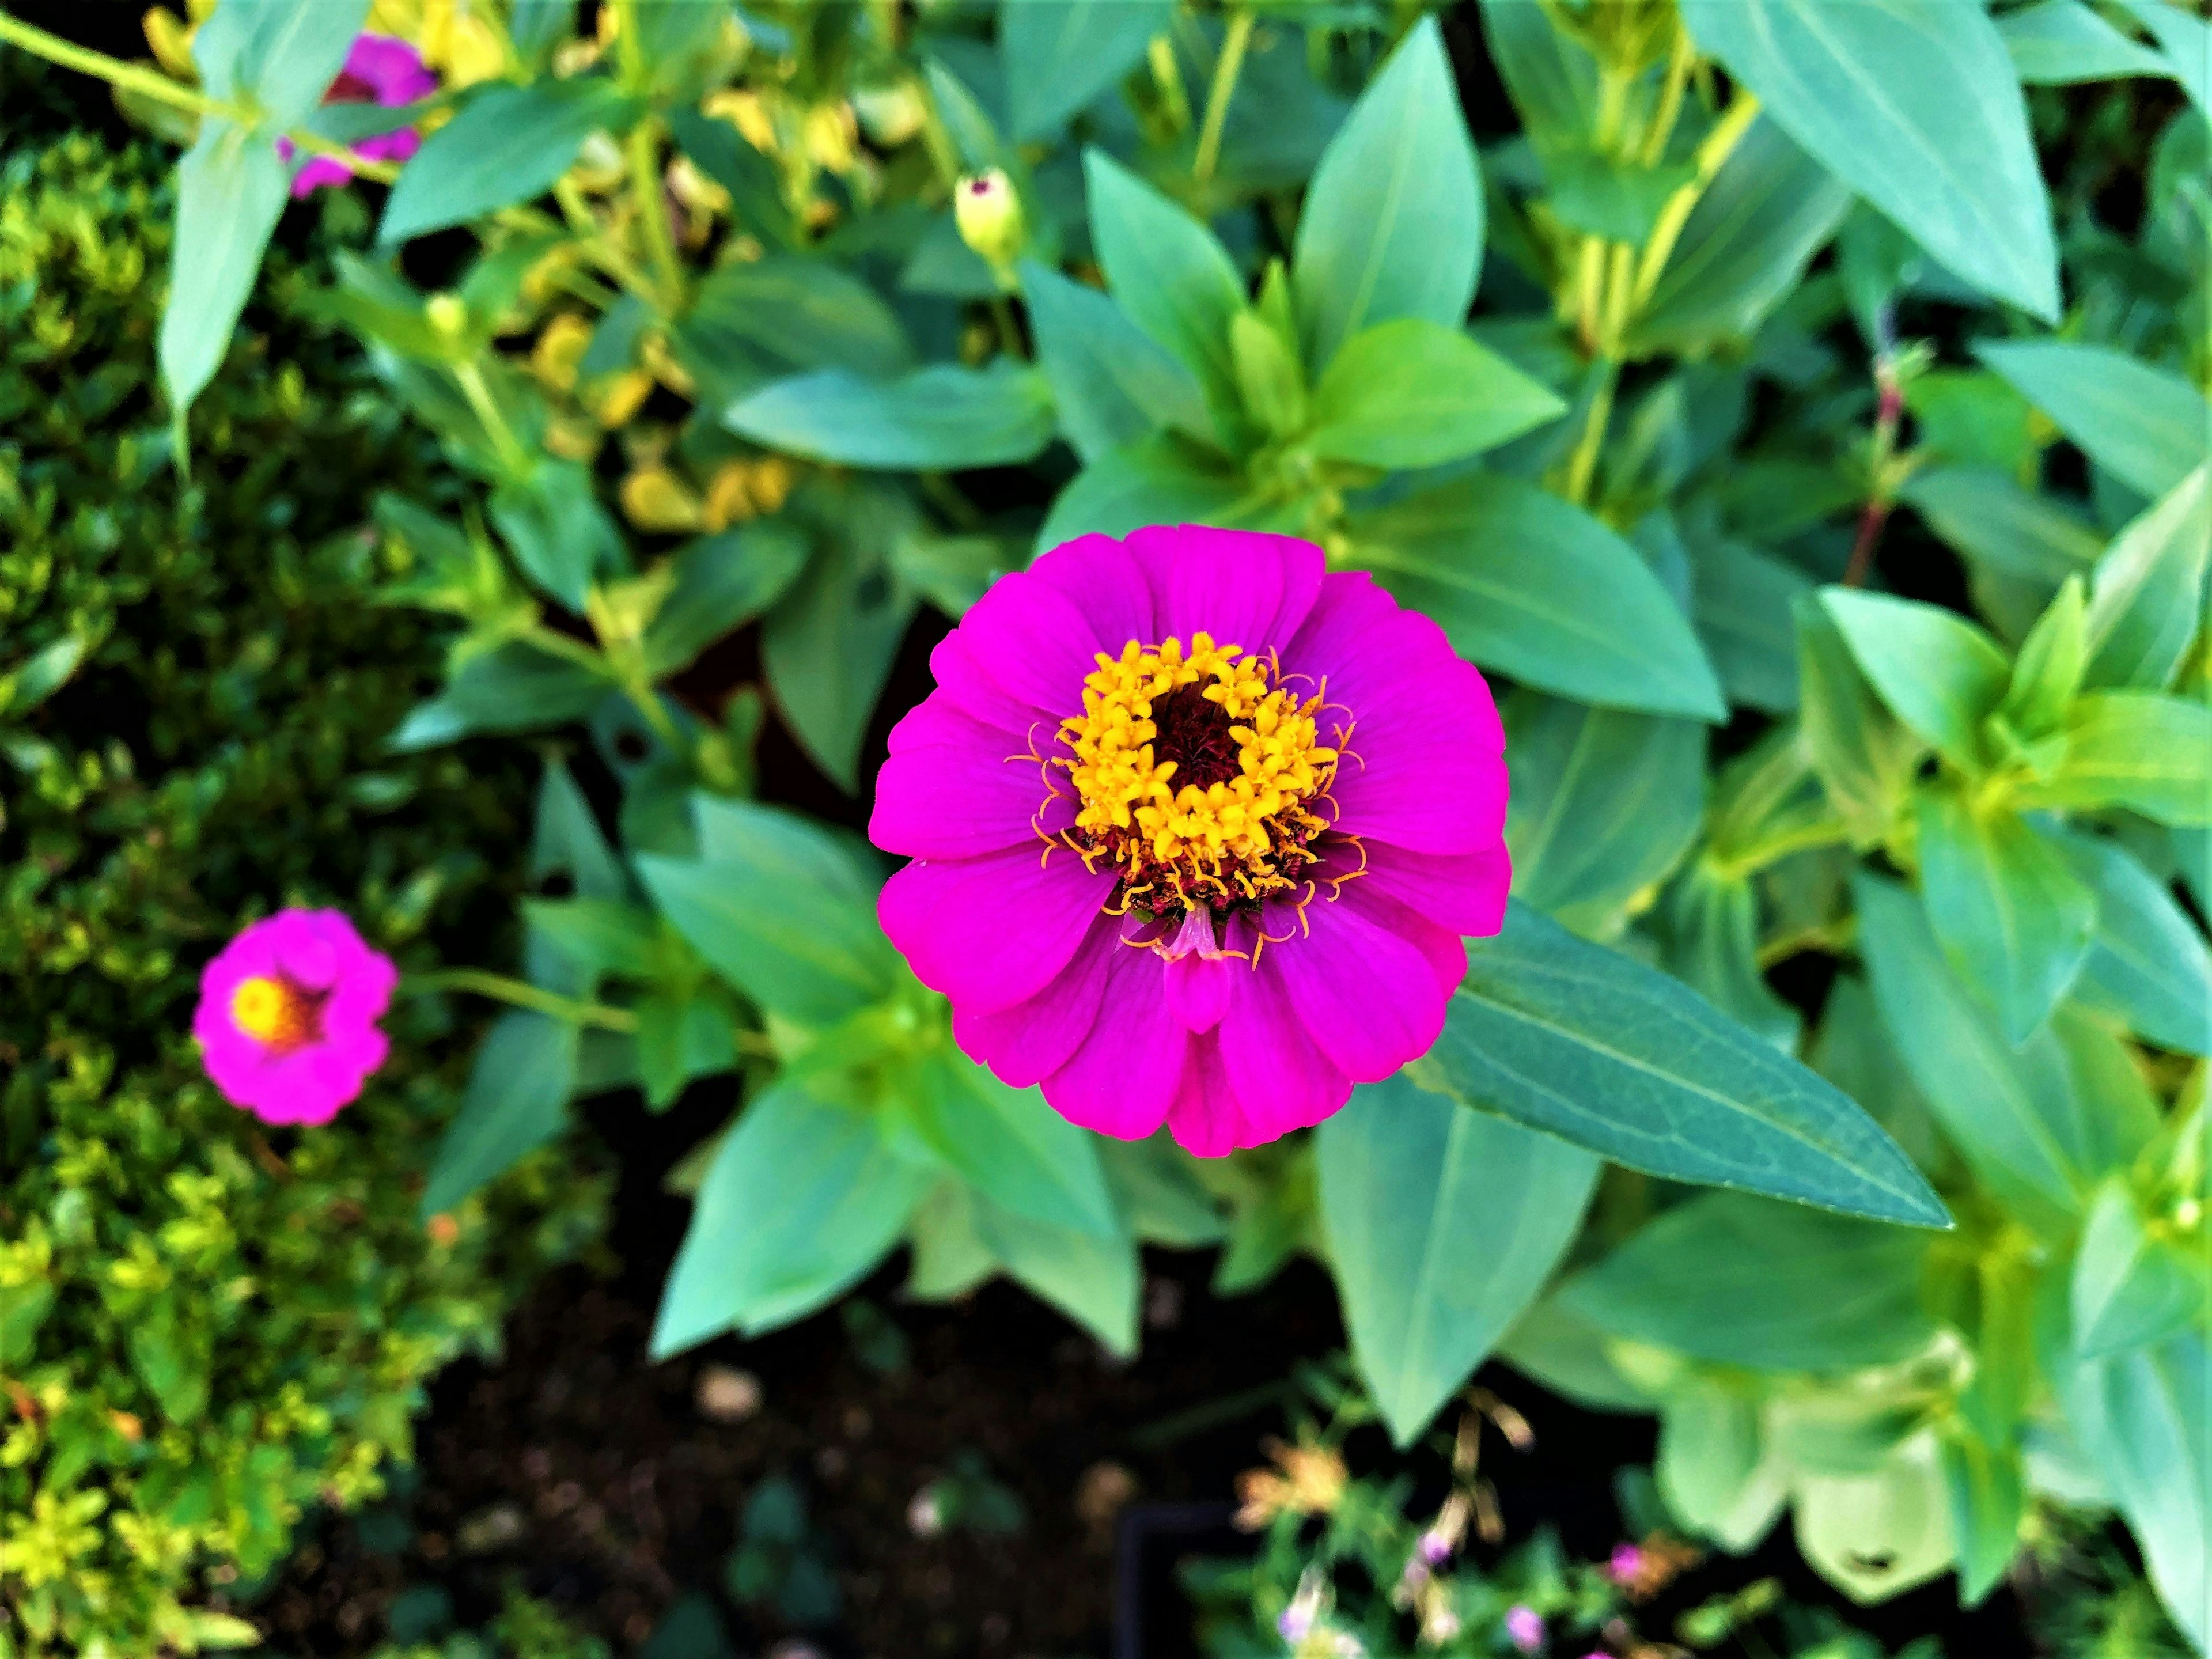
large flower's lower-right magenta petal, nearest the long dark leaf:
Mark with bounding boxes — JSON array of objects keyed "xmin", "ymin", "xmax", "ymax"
[{"xmin": 1267, "ymin": 882, "xmax": 1464, "ymax": 1084}]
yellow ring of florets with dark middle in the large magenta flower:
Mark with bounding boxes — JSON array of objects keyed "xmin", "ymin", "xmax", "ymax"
[{"xmin": 1053, "ymin": 632, "xmax": 1338, "ymax": 914}]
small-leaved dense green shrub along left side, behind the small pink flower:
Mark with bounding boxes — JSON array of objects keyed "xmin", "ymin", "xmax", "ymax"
[{"xmin": 0, "ymin": 137, "xmax": 600, "ymax": 1659}]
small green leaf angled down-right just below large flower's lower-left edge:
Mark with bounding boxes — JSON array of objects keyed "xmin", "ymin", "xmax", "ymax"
[{"xmin": 900, "ymin": 1048, "xmax": 1122, "ymax": 1238}]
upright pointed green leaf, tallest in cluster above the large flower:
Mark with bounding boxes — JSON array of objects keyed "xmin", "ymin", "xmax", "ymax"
[{"xmin": 1291, "ymin": 18, "xmax": 1482, "ymax": 372}]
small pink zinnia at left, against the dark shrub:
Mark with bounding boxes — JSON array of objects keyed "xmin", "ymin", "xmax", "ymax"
[{"xmin": 192, "ymin": 909, "xmax": 400, "ymax": 1124}]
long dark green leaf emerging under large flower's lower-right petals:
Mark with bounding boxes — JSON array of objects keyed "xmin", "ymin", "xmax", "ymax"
[{"xmin": 1409, "ymin": 903, "xmax": 1946, "ymax": 1228}]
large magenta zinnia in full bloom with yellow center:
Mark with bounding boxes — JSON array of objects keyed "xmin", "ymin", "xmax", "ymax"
[{"xmin": 869, "ymin": 524, "xmax": 1511, "ymax": 1157}]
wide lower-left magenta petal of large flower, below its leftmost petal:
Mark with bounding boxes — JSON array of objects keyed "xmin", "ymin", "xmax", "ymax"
[{"xmin": 876, "ymin": 845, "xmax": 1115, "ymax": 1013}]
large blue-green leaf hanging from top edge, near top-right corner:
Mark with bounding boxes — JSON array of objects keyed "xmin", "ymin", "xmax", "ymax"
[{"xmin": 1683, "ymin": 0, "xmax": 2059, "ymax": 321}]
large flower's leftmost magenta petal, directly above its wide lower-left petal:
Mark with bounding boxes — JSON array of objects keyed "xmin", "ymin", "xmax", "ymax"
[{"xmin": 867, "ymin": 712, "xmax": 1075, "ymax": 858}]
